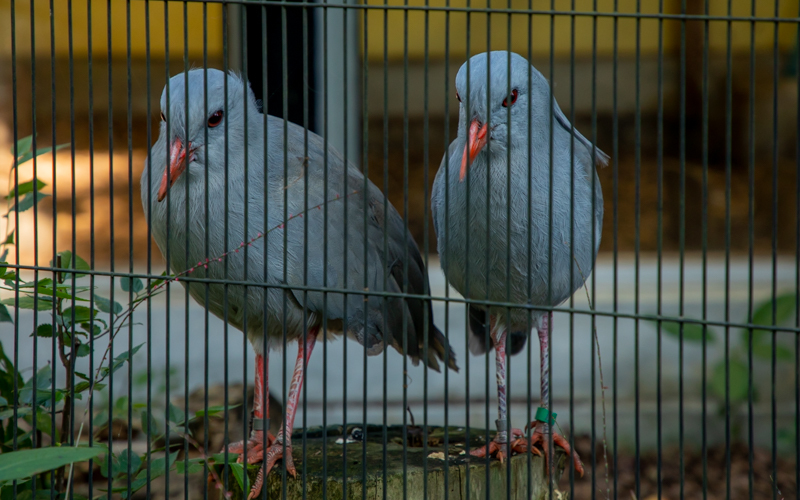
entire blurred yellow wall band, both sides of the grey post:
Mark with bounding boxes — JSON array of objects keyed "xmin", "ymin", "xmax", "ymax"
[{"xmin": 0, "ymin": 0, "xmax": 800, "ymax": 61}]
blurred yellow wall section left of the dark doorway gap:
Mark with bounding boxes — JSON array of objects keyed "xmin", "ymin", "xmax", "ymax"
[{"xmin": 0, "ymin": 0, "xmax": 222, "ymax": 60}]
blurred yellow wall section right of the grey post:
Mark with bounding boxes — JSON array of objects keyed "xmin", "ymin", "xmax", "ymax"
[{"xmin": 364, "ymin": 0, "xmax": 798, "ymax": 61}]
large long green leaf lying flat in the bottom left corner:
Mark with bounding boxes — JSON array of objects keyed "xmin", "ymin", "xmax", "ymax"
[{"xmin": 0, "ymin": 446, "xmax": 103, "ymax": 481}]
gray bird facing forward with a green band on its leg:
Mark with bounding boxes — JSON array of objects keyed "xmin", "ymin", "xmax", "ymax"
[{"xmin": 431, "ymin": 51, "xmax": 608, "ymax": 474}]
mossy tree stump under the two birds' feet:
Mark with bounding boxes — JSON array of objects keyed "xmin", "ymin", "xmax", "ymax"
[{"xmin": 220, "ymin": 425, "xmax": 567, "ymax": 500}]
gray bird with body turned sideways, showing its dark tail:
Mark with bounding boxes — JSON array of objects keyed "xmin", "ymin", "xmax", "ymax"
[{"xmin": 141, "ymin": 69, "xmax": 458, "ymax": 497}]
